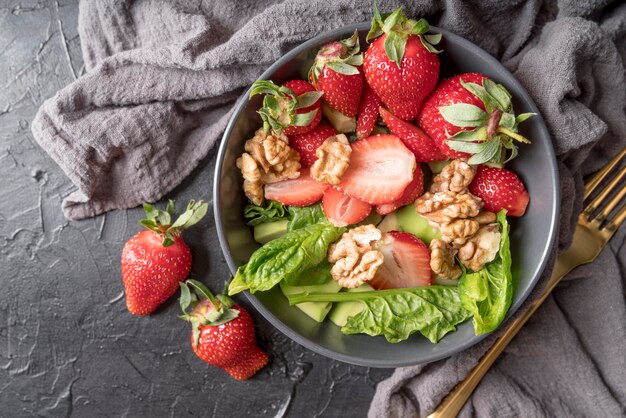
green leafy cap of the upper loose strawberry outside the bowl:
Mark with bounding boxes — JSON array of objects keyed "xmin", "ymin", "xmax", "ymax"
[{"xmin": 139, "ymin": 200, "xmax": 209, "ymax": 247}]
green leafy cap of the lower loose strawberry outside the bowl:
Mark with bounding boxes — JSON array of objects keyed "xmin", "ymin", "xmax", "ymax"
[{"xmin": 179, "ymin": 279, "xmax": 239, "ymax": 347}]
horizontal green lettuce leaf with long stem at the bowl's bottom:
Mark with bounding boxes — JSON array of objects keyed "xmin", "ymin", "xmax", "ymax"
[{"xmin": 289, "ymin": 286, "xmax": 472, "ymax": 344}]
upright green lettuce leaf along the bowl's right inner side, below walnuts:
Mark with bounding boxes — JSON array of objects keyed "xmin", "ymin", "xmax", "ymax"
[{"xmin": 459, "ymin": 210, "xmax": 513, "ymax": 334}]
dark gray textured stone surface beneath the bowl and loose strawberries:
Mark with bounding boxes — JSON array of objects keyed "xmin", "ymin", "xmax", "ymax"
[{"xmin": 0, "ymin": 0, "xmax": 391, "ymax": 417}]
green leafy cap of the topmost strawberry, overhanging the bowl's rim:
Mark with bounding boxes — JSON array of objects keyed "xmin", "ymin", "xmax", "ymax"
[{"xmin": 366, "ymin": 0, "xmax": 441, "ymax": 68}]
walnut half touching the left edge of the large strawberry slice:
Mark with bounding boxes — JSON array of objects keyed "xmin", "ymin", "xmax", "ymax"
[{"xmin": 311, "ymin": 134, "xmax": 352, "ymax": 185}]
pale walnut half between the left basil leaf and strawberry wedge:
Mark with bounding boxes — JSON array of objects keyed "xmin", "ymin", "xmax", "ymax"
[{"xmin": 328, "ymin": 225, "xmax": 384, "ymax": 288}]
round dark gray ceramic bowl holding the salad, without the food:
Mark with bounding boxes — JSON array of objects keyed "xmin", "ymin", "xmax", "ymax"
[{"xmin": 213, "ymin": 24, "xmax": 559, "ymax": 367}]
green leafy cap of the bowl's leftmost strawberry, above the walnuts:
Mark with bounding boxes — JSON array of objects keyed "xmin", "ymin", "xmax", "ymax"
[{"xmin": 250, "ymin": 80, "xmax": 322, "ymax": 135}]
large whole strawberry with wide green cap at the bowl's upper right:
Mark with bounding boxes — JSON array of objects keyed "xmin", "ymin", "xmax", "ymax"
[{"xmin": 417, "ymin": 73, "xmax": 533, "ymax": 165}]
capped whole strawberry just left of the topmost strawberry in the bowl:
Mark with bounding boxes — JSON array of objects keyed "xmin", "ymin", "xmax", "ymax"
[{"xmin": 309, "ymin": 31, "xmax": 363, "ymax": 117}]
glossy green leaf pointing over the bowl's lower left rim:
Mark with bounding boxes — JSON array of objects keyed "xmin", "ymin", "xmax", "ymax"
[{"xmin": 228, "ymin": 222, "xmax": 346, "ymax": 295}]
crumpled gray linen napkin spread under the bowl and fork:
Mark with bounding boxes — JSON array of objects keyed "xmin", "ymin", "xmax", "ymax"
[{"xmin": 33, "ymin": 0, "xmax": 626, "ymax": 417}]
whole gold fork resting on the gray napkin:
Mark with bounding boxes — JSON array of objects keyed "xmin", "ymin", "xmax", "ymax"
[{"xmin": 428, "ymin": 148, "xmax": 626, "ymax": 418}]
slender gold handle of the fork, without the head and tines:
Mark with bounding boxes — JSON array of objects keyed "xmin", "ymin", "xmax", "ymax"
[{"xmin": 428, "ymin": 251, "xmax": 575, "ymax": 418}]
